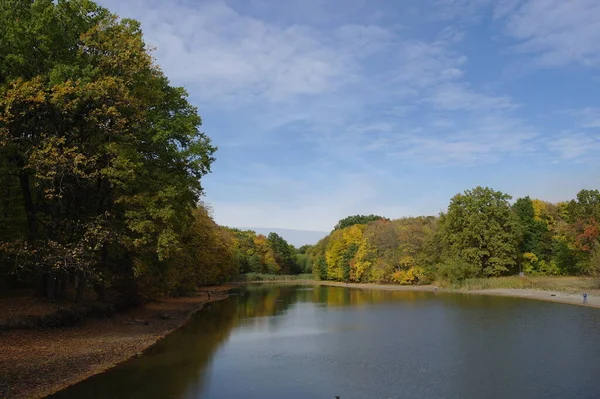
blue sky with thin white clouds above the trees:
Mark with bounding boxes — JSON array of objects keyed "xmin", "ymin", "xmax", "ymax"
[{"xmin": 100, "ymin": 0, "xmax": 600, "ymax": 231}]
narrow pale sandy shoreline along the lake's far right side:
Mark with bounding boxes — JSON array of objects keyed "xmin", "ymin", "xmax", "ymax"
[{"xmin": 241, "ymin": 280, "xmax": 600, "ymax": 309}]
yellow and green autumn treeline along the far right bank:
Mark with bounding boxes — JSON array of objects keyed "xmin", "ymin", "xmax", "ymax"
[{"xmin": 308, "ymin": 187, "xmax": 600, "ymax": 284}]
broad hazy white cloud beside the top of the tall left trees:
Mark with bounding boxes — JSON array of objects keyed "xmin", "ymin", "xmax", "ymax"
[{"xmin": 105, "ymin": 0, "xmax": 360, "ymax": 103}]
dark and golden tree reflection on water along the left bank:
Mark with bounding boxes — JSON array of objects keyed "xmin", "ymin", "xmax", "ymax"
[{"xmin": 49, "ymin": 286, "xmax": 309, "ymax": 399}]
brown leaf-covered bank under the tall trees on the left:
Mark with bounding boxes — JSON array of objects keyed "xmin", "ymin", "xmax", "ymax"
[{"xmin": 0, "ymin": 284, "xmax": 236, "ymax": 399}]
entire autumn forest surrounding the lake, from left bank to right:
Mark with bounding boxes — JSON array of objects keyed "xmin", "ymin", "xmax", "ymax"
[{"xmin": 0, "ymin": 0, "xmax": 600, "ymax": 310}]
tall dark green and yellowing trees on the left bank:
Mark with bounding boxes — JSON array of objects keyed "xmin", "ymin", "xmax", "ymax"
[{"xmin": 0, "ymin": 0, "xmax": 237, "ymax": 299}]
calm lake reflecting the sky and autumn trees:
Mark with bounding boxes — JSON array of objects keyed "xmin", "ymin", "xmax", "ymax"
[{"xmin": 51, "ymin": 285, "xmax": 600, "ymax": 399}]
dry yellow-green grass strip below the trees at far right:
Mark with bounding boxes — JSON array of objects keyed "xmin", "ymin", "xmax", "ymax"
[{"xmin": 449, "ymin": 276, "xmax": 600, "ymax": 292}]
